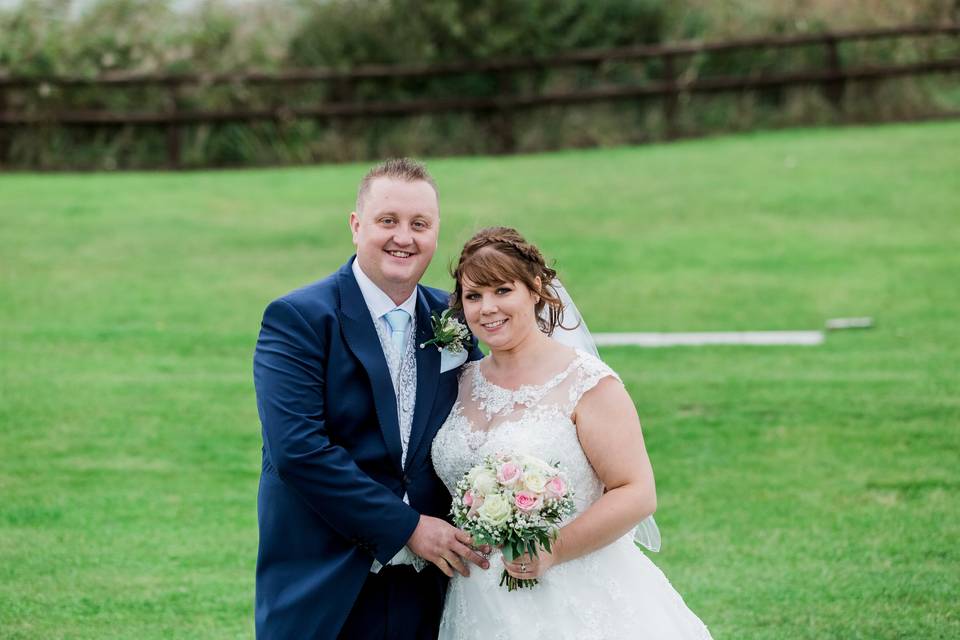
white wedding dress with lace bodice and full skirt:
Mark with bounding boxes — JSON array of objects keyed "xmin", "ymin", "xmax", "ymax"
[{"xmin": 432, "ymin": 351, "xmax": 710, "ymax": 640}]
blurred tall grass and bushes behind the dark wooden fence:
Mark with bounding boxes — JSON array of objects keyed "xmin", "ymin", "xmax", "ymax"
[{"xmin": 0, "ymin": 0, "xmax": 960, "ymax": 169}]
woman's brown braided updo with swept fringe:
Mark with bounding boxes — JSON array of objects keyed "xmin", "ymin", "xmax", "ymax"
[{"xmin": 450, "ymin": 227, "xmax": 563, "ymax": 336}]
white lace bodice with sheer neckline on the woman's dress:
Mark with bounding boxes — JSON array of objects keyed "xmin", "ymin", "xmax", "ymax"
[{"xmin": 432, "ymin": 351, "xmax": 620, "ymax": 515}]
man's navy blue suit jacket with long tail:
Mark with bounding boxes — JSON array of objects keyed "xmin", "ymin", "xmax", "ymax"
[{"xmin": 253, "ymin": 259, "xmax": 480, "ymax": 640}]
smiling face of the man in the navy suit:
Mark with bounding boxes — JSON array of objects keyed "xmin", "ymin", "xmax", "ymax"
[{"xmin": 350, "ymin": 178, "xmax": 440, "ymax": 303}]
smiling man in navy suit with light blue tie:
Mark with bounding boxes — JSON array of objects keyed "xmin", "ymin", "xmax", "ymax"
[{"xmin": 253, "ymin": 159, "xmax": 488, "ymax": 640}]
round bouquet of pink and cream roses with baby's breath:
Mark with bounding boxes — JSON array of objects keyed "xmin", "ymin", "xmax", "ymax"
[{"xmin": 450, "ymin": 454, "xmax": 574, "ymax": 591}]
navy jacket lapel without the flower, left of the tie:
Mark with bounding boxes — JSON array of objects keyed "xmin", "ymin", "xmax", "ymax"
[{"xmin": 338, "ymin": 260, "xmax": 404, "ymax": 473}]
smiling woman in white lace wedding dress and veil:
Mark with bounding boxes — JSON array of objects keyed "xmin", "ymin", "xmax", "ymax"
[{"xmin": 432, "ymin": 227, "xmax": 710, "ymax": 640}]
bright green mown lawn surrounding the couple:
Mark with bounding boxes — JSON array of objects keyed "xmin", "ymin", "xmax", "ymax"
[{"xmin": 0, "ymin": 123, "xmax": 960, "ymax": 640}]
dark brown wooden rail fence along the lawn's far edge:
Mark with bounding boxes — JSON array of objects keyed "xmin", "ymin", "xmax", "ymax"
[{"xmin": 0, "ymin": 25, "xmax": 960, "ymax": 167}]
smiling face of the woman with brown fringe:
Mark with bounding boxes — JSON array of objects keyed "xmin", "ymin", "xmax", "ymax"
[{"xmin": 462, "ymin": 278, "xmax": 539, "ymax": 349}]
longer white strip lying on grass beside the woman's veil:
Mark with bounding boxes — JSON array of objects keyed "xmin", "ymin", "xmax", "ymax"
[{"xmin": 593, "ymin": 331, "xmax": 823, "ymax": 347}]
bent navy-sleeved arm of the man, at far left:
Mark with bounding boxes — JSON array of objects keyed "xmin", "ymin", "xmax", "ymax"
[{"xmin": 253, "ymin": 299, "xmax": 420, "ymax": 564}]
